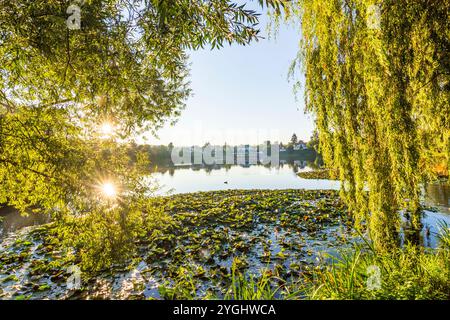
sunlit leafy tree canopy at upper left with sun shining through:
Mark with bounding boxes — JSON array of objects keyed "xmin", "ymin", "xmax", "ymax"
[{"xmin": 0, "ymin": 0, "xmax": 281, "ymax": 229}]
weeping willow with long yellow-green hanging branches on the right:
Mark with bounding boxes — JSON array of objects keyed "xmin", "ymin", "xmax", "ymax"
[{"xmin": 286, "ymin": 0, "xmax": 450, "ymax": 250}]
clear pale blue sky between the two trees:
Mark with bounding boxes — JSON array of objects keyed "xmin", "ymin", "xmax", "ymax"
[{"xmin": 142, "ymin": 6, "xmax": 313, "ymax": 146}]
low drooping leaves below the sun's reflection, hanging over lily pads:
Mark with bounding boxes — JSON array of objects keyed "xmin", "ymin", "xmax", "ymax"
[{"xmin": 57, "ymin": 199, "xmax": 173, "ymax": 272}]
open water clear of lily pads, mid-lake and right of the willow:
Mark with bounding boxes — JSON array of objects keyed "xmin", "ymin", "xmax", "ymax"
[{"xmin": 153, "ymin": 164, "xmax": 450, "ymax": 247}]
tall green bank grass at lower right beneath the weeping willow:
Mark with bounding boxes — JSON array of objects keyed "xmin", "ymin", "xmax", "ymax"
[{"xmin": 228, "ymin": 223, "xmax": 450, "ymax": 300}]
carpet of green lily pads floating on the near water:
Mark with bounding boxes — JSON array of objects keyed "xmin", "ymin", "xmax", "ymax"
[{"xmin": 0, "ymin": 190, "xmax": 351, "ymax": 299}]
